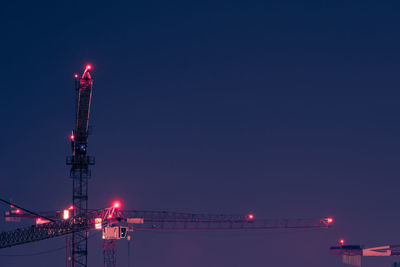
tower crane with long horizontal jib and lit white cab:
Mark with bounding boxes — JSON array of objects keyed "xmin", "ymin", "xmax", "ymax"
[{"xmin": 0, "ymin": 204, "xmax": 333, "ymax": 267}]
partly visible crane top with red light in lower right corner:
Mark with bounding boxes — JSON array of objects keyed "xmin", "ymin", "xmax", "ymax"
[{"xmin": 330, "ymin": 239, "xmax": 400, "ymax": 267}]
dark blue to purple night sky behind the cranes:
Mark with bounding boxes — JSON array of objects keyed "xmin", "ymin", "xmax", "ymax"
[{"xmin": 0, "ymin": 0, "xmax": 400, "ymax": 267}]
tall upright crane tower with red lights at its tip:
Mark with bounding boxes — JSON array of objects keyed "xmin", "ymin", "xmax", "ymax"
[{"xmin": 67, "ymin": 65, "xmax": 94, "ymax": 267}]
